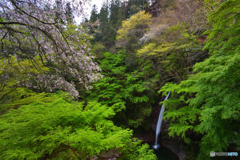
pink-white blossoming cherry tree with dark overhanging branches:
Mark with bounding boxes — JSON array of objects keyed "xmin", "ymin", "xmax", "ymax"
[{"xmin": 0, "ymin": 0, "xmax": 102, "ymax": 97}]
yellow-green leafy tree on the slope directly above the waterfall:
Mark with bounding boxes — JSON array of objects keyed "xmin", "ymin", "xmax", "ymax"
[{"xmin": 136, "ymin": 23, "xmax": 201, "ymax": 83}]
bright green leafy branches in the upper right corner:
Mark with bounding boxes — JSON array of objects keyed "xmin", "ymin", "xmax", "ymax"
[{"xmin": 204, "ymin": 0, "xmax": 240, "ymax": 54}]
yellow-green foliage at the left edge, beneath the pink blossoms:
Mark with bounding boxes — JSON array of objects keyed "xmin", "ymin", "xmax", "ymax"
[{"xmin": 0, "ymin": 56, "xmax": 49, "ymax": 114}]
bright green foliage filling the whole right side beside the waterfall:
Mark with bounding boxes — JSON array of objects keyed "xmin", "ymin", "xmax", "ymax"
[{"xmin": 160, "ymin": 0, "xmax": 240, "ymax": 159}]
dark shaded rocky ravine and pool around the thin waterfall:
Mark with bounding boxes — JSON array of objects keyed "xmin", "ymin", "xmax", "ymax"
[{"xmin": 134, "ymin": 91, "xmax": 185, "ymax": 160}]
